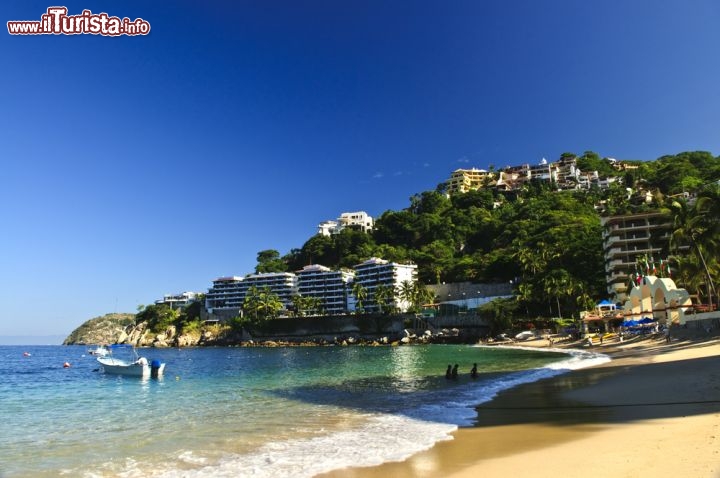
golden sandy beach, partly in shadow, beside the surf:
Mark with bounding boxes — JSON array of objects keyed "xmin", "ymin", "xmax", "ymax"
[{"xmin": 323, "ymin": 329, "xmax": 720, "ymax": 478}]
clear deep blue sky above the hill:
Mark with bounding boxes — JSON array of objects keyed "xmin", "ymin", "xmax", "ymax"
[{"xmin": 0, "ymin": 0, "xmax": 720, "ymax": 342}]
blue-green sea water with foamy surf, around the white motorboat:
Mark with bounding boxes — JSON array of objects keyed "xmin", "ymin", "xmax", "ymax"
[{"xmin": 0, "ymin": 345, "xmax": 609, "ymax": 478}]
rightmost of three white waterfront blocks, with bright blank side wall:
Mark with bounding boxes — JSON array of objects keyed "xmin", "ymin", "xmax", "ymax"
[{"xmin": 354, "ymin": 257, "xmax": 417, "ymax": 312}]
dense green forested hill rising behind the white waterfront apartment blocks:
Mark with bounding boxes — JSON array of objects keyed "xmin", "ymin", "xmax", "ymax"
[{"xmin": 257, "ymin": 152, "xmax": 720, "ymax": 320}]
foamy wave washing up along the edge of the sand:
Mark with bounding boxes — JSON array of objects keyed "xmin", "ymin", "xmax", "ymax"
[{"xmin": 105, "ymin": 347, "xmax": 610, "ymax": 478}]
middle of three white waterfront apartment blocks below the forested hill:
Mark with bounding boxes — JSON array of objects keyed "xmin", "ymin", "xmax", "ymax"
[{"xmin": 297, "ymin": 264, "xmax": 355, "ymax": 315}]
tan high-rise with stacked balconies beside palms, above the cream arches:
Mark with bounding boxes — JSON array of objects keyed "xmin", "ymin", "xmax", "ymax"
[{"xmin": 601, "ymin": 211, "xmax": 672, "ymax": 302}]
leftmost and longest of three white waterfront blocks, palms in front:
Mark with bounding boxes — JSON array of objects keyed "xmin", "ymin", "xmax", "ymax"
[{"xmin": 205, "ymin": 272, "xmax": 297, "ymax": 313}]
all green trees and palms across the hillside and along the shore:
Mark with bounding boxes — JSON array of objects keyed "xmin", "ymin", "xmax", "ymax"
[{"xmin": 111, "ymin": 151, "xmax": 720, "ymax": 333}]
